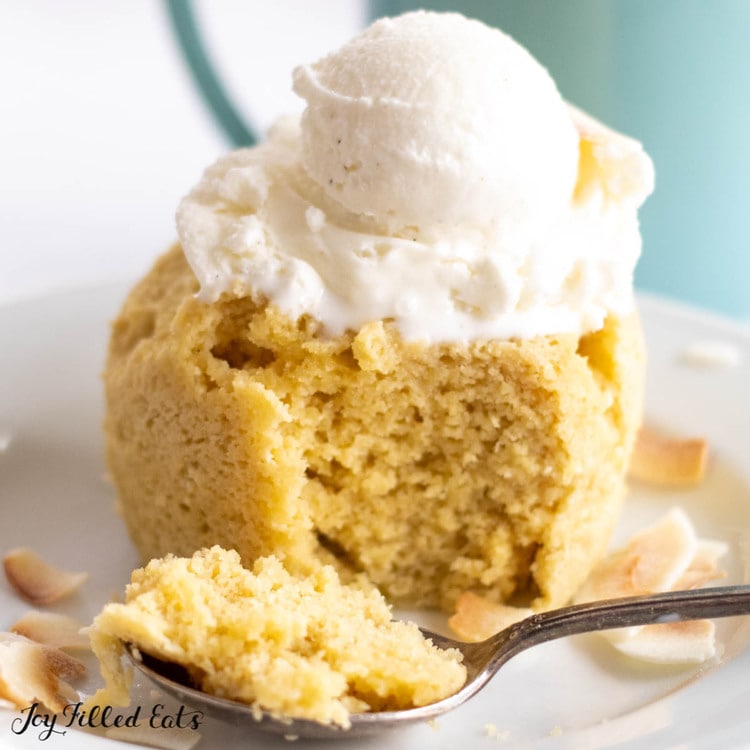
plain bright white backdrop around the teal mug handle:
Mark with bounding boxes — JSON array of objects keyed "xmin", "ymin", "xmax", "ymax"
[{"xmin": 0, "ymin": 0, "xmax": 365, "ymax": 302}]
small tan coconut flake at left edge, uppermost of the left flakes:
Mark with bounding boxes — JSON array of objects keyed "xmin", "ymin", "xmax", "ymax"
[{"xmin": 3, "ymin": 547, "xmax": 88, "ymax": 605}]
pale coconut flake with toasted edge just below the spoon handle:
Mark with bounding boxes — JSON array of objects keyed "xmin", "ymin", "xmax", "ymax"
[{"xmin": 617, "ymin": 620, "xmax": 716, "ymax": 664}]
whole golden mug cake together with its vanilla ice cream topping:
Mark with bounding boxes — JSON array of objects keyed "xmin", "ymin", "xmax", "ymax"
[{"xmin": 105, "ymin": 12, "xmax": 653, "ymax": 609}]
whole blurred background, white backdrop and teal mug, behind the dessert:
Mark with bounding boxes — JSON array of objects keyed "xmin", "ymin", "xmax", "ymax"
[{"xmin": 0, "ymin": 0, "xmax": 750, "ymax": 322}]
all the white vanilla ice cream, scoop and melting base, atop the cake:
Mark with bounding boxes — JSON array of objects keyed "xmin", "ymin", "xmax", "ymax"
[{"xmin": 177, "ymin": 12, "xmax": 653, "ymax": 342}]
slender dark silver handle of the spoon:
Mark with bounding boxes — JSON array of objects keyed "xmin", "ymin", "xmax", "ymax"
[{"xmin": 488, "ymin": 585, "xmax": 750, "ymax": 668}]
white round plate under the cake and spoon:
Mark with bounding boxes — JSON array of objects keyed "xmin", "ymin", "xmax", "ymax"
[{"xmin": 0, "ymin": 284, "xmax": 750, "ymax": 750}]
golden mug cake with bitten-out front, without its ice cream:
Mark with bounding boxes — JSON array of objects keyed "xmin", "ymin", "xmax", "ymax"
[{"xmin": 105, "ymin": 247, "xmax": 644, "ymax": 609}]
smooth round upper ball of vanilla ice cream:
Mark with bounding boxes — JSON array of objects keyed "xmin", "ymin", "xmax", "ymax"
[{"xmin": 294, "ymin": 11, "xmax": 578, "ymax": 235}]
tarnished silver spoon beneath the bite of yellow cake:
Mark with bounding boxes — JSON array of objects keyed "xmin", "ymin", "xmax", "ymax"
[{"xmin": 126, "ymin": 585, "xmax": 750, "ymax": 738}]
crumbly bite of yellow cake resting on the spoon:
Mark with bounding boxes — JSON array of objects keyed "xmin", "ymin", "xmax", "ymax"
[{"xmin": 91, "ymin": 547, "xmax": 466, "ymax": 728}]
